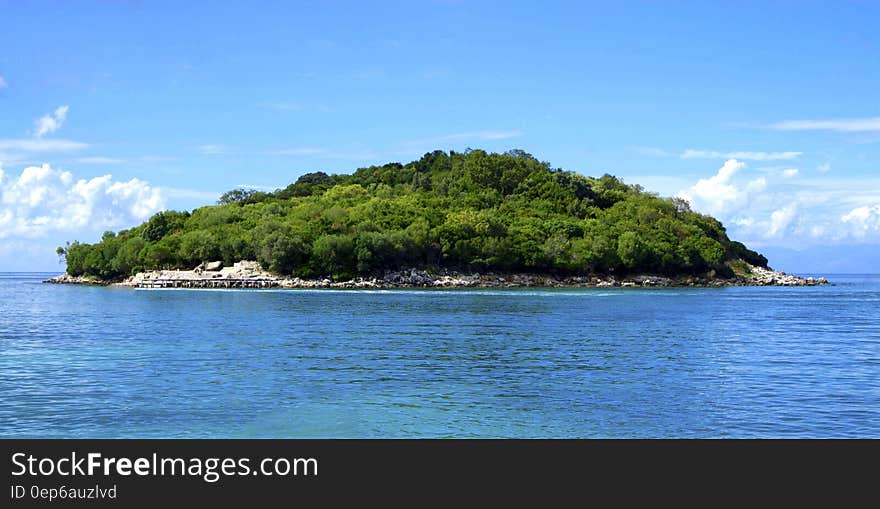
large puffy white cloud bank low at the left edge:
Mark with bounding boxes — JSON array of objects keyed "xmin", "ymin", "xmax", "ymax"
[{"xmin": 0, "ymin": 164, "xmax": 165, "ymax": 238}]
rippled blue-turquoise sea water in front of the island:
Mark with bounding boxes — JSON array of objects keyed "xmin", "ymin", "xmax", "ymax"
[{"xmin": 0, "ymin": 273, "xmax": 880, "ymax": 438}]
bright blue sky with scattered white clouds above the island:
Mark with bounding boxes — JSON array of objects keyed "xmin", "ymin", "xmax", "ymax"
[{"xmin": 0, "ymin": 0, "xmax": 880, "ymax": 271}]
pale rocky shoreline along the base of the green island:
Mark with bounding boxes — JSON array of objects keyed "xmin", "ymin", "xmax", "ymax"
[{"xmin": 45, "ymin": 261, "xmax": 828, "ymax": 289}]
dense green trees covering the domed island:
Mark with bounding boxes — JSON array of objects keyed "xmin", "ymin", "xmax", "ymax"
[{"xmin": 58, "ymin": 150, "xmax": 767, "ymax": 279}]
